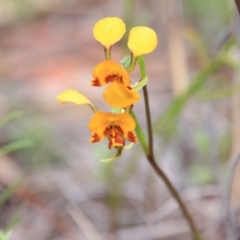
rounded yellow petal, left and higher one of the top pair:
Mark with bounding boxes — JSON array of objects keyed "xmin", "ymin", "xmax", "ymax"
[{"xmin": 93, "ymin": 17, "xmax": 126, "ymax": 49}]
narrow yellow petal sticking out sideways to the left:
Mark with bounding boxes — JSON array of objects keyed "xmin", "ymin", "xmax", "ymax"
[{"xmin": 57, "ymin": 89, "xmax": 92, "ymax": 105}]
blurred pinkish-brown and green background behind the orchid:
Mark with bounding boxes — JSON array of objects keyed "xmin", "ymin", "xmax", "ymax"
[{"xmin": 0, "ymin": 0, "xmax": 240, "ymax": 240}]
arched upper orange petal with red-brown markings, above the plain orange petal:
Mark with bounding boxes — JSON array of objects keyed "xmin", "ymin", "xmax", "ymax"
[{"xmin": 91, "ymin": 60, "xmax": 130, "ymax": 87}]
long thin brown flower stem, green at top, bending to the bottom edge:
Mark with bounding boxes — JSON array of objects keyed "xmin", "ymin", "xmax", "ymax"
[{"xmin": 138, "ymin": 56, "xmax": 202, "ymax": 240}]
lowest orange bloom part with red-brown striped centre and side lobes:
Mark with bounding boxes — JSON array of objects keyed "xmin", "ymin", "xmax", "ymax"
[{"xmin": 88, "ymin": 111, "xmax": 138, "ymax": 149}]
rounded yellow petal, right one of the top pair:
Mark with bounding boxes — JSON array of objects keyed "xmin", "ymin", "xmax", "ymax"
[{"xmin": 128, "ymin": 27, "xmax": 158, "ymax": 57}]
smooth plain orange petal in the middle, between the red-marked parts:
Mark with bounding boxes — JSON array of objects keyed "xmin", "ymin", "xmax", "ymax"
[{"xmin": 103, "ymin": 82, "xmax": 140, "ymax": 108}]
